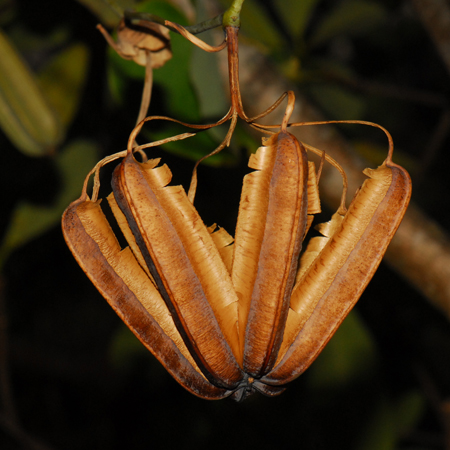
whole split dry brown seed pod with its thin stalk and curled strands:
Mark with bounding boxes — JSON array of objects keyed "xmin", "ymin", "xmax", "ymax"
[{"xmin": 62, "ymin": 20, "xmax": 411, "ymax": 401}]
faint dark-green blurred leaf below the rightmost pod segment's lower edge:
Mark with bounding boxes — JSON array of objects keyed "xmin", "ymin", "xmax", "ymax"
[{"xmin": 308, "ymin": 311, "xmax": 377, "ymax": 389}]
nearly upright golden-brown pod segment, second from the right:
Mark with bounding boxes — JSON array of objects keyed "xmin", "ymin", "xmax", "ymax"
[{"xmin": 232, "ymin": 131, "xmax": 308, "ymax": 377}]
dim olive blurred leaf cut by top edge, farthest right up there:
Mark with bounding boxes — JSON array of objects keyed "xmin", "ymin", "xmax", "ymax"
[{"xmin": 309, "ymin": 0, "xmax": 387, "ymax": 46}]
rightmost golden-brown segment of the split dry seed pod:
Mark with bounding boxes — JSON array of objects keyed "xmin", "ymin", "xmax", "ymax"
[{"xmin": 262, "ymin": 158, "xmax": 411, "ymax": 385}]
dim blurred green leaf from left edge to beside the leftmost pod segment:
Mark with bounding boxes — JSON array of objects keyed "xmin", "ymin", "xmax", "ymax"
[{"xmin": 0, "ymin": 140, "xmax": 97, "ymax": 267}]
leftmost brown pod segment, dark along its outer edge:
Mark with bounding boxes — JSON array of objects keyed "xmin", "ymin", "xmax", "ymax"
[{"xmin": 62, "ymin": 198, "xmax": 232, "ymax": 399}]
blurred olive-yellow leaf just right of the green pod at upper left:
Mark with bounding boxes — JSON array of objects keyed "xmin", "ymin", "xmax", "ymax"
[{"xmin": 39, "ymin": 44, "xmax": 89, "ymax": 128}]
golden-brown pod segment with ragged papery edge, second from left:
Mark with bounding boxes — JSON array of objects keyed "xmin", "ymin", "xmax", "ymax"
[{"xmin": 112, "ymin": 153, "xmax": 243, "ymax": 389}]
